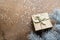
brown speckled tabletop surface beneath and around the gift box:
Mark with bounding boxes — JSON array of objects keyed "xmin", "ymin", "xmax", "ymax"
[{"xmin": 0, "ymin": 0, "xmax": 60, "ymax": 40}]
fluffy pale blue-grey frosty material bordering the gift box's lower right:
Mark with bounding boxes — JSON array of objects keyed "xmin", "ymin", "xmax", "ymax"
[{"xmin": 28, "ymin": 9, "xmax": 60, "ymax": 40}]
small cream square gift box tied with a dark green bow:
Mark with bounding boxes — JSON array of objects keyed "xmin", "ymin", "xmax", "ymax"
[{"xmin": 32, "ymin": 13, "xmax": 52, "ymax": 31}]
